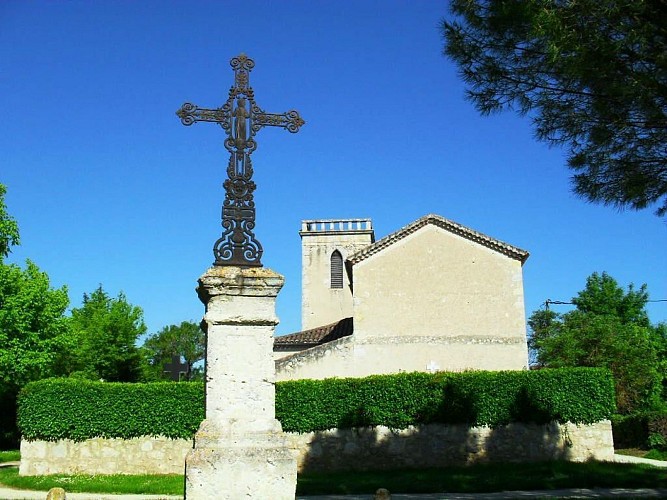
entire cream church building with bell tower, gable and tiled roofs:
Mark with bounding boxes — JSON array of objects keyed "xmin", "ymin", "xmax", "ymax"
[{"xmin": 274, "ymin": 215, "xmax": 528, "ymax": 380}]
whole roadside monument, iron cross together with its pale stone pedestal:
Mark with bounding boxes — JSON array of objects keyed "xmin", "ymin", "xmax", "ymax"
[{"xmin": 177, "ymin": 54, "xmax": 304, "ymax": 500}]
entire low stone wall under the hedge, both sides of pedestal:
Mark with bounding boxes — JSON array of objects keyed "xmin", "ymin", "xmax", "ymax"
[{"xmin": 19, "ymin": 421, "xmax": 614, "ymax": 475}]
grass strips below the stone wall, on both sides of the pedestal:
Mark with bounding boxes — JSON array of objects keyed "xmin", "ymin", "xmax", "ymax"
[{"xmin": 0, "ymin": 462, "xmax": 667, "ymax": 495}]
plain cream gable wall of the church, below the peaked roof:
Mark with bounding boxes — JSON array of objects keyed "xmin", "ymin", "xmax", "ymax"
[{"xmin": 353, "ymin": 225, "xmax": 527, "ymax": 371}]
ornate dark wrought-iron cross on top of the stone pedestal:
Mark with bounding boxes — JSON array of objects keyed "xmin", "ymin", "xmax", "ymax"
[{"xmin": 176, "ymin": 54, "xmax": 305, "ymax": 267}]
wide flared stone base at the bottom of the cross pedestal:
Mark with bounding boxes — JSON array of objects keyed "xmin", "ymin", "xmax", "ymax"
[{"xmin": 185, "ymin": 424, "xmax": 297, "ymax": 500}]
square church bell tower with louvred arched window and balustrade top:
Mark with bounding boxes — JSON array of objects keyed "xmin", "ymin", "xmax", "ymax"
[{"xmin": 299, "ymin": 219, "xmax": 375, "ymax": 330}]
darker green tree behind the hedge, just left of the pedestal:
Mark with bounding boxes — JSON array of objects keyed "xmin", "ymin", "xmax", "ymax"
[{"xmin": 143, "ymin": 321, "xmax": 206, "ymax": 380}]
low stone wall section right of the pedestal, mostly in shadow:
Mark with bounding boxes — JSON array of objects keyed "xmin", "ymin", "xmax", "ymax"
[{"xmin": 290, "ymin": 421, "xmax": 614, "ymax": 472}]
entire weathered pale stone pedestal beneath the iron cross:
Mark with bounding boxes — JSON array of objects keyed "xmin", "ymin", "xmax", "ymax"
[{"xmin": 185, "ymin": 267, "xmax": 296, "ymax": 500}]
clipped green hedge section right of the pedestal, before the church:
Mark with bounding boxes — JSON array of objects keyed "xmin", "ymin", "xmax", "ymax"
[{"xmin": 276, "ymin": 369, "xmax": 614, "ymax": 432}]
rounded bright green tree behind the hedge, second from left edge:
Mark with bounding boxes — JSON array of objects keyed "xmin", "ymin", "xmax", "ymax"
[{"xmin": 71, "ymin": 285, "xmax": 146, "ymax": 382}]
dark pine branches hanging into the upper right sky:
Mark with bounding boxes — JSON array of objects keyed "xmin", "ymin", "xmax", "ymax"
[{"xmin": 442, "ymin": 0, "xmax": 667, "ymax": 215}]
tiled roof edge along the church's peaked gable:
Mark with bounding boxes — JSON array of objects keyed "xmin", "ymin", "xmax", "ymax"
[{"xmin": 347, "ymin": 214, "xmax": 530, "ymax": 265}]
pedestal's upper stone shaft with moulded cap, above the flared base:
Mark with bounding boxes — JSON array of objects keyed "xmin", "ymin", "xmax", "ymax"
[{"xmin": 197, "ymin": 267, "xmax": 284, "ymax": 432}]
